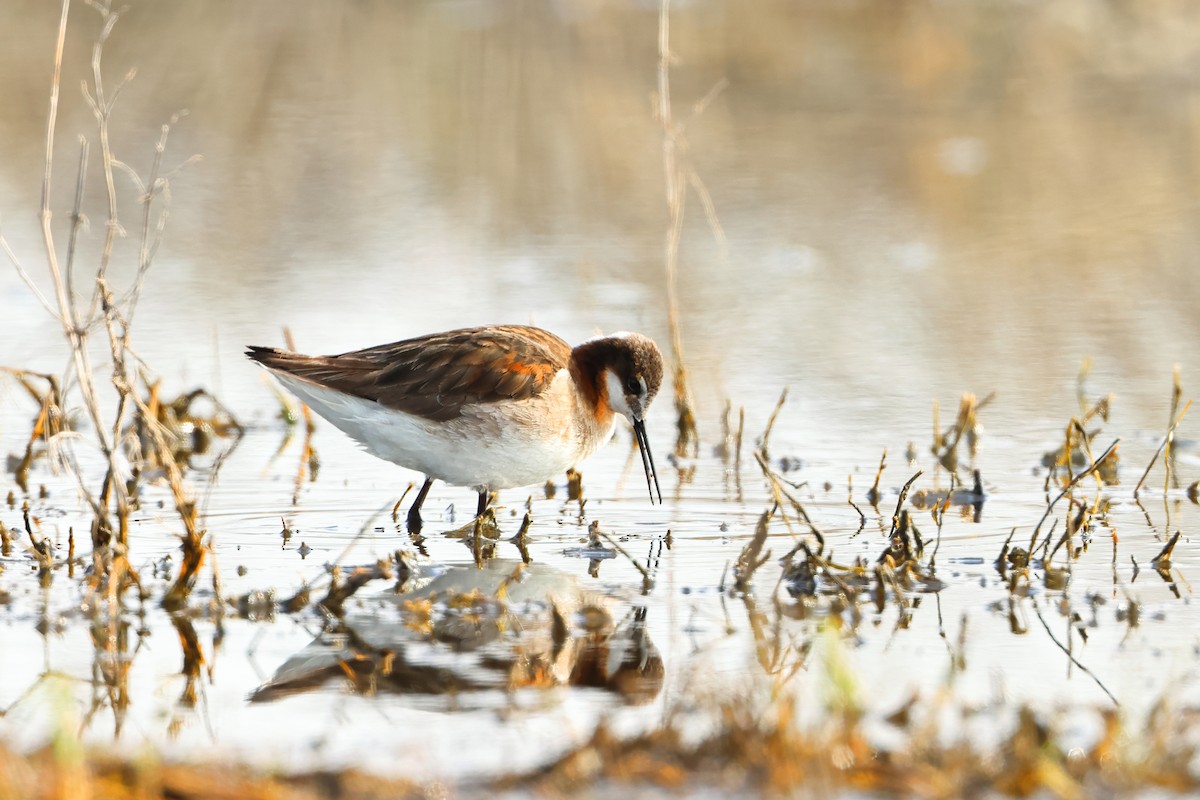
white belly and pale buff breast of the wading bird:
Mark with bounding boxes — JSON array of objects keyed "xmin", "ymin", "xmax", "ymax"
[{"xmin": 272, "ymin": 369, "xmax": 613, "ymax": 491}]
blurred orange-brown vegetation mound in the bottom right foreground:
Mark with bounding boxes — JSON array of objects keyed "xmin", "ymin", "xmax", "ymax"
[{"xmin": 498, "ymin": 694, "xmax": 1200, "ymax": 799}]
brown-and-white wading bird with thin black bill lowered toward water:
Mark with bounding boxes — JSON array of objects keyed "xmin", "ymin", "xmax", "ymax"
[{"xmin": 246, "ymin": 325, "xmax": 662, "ymax": 533}]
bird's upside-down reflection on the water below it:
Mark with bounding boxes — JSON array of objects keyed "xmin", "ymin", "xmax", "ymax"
[{"xmin": 250, "ymin": 559, "xmax": 664, "ymax": 710}]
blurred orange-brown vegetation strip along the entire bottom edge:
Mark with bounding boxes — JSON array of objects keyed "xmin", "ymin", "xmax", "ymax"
[{"xmin": 0, "ymin": 696, "xmax": 1200, "ymax": 800}]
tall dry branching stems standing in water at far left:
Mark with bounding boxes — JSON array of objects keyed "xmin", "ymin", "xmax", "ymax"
[{"xmin": 0, "ymin": 0, "xmax": 241, "ymax": 608}]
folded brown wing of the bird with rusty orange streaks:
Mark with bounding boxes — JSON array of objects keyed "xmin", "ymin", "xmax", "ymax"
[{"xmin": 246, "ymin": 325, "xmax": 571, "ymax": 421}]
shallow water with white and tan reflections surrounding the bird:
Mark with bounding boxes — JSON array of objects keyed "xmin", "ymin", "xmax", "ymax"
[{"xmin": 0, "ymin": 2, "xmax": 1200, "ymax": 777}]
